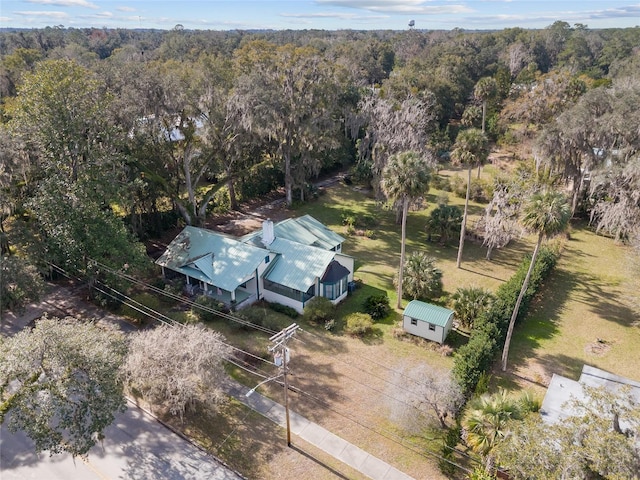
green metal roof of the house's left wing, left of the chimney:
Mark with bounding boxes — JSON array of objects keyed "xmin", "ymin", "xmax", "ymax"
[{"xmin": 156, "ymin": 226, "xmax": 269, "ymax": 291}]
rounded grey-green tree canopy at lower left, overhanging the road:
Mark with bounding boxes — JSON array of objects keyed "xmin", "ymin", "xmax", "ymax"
[{"xmin": 0, "ymin": 317, "xmax": 127, "ymax": 456}]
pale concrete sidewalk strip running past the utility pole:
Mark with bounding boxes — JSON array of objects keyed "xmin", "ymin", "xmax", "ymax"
[{"xmin": 222, "ymin": 379, "xmax": 413, "ymax": 480}]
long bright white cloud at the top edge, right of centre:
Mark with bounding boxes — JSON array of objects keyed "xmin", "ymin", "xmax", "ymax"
[{"xmin": 315, "ymin": 0, "xmax": 473, "ymax": 15}]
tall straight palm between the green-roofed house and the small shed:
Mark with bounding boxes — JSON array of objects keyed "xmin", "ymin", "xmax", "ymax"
[{"xmin": 381, "ymin": 151, "xmax": 431, "ymax": 308}]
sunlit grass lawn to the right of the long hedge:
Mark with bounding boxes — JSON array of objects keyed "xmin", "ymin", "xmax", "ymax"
[{"xmin": 495, "ymin": 224, "xmax": 640, "ymax": 395}]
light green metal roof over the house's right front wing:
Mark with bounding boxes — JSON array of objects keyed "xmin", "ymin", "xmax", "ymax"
[{"xmin": 265, "ymin": 238, "xmax": 335, "ymax": 292}]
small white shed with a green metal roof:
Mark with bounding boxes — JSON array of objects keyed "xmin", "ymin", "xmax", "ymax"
[{"xmin": 402, "ymin": 300, "xmax": 454, "ymax": 343}]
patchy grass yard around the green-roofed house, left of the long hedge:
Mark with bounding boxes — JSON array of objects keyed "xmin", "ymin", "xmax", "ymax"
[{"xmin": 164, "ymin": 178, "xmax": 532, "ymax": 479}]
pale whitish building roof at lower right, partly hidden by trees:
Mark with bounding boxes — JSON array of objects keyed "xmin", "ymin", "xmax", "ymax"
[{"xmin": 540, "ymin": 365, "xmax": 640, "ymax": 424}]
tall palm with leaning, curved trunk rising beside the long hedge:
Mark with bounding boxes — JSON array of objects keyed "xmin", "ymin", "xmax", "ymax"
[{"xmin": 502, "ymin": 190, "xmax": 571, "ymax": 372}]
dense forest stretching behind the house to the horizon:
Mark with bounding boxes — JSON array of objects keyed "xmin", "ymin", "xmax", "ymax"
[{"xmin": 0, "ymin": 21, "xmax": 640, "ymax": 307}]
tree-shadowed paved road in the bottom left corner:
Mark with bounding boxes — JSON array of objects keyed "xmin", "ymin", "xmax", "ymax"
[{"xmin": 0, "ymin": 405, "xmax": 243, "ymax": 480}]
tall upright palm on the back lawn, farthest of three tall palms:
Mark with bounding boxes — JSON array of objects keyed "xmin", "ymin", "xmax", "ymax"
[{"xmin": 451, "ymin": 128, "xmax": 489, "ymax": 268}]
